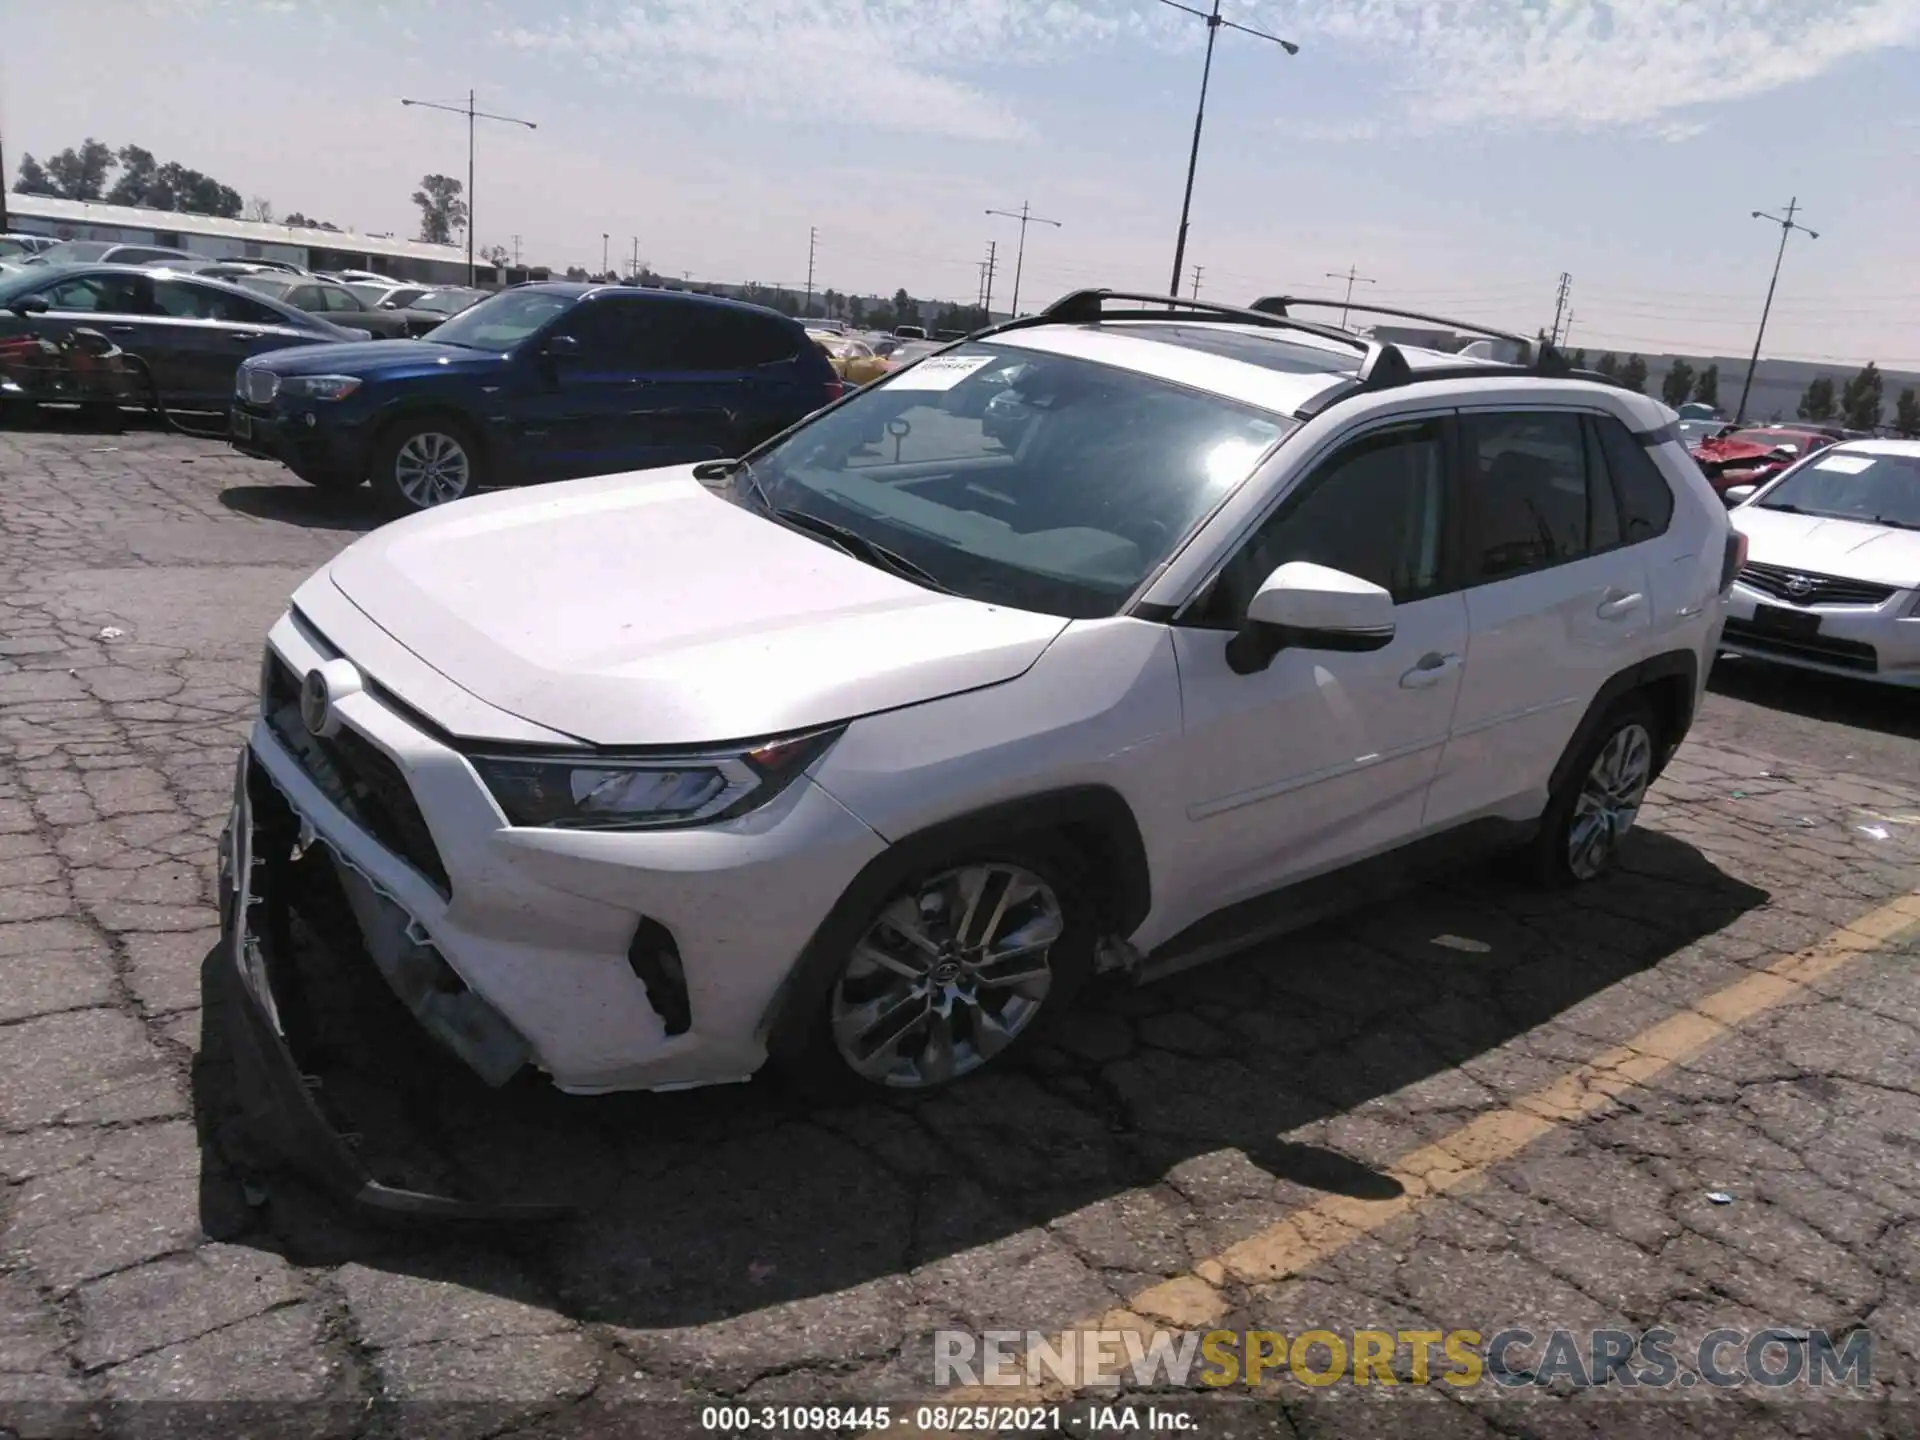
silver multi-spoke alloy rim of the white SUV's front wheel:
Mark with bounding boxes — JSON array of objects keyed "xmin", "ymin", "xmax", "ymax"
[{"xmin": 829, "ymin": 862, "xmax": 1066, "ymax": 1089}]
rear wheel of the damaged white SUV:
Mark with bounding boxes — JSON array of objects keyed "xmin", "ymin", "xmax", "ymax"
[{"xmin": 1532, "ymin": 697, "xmax": 1661, "ymax": 889}]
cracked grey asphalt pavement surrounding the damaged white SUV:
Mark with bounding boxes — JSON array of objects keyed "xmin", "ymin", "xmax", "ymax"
[{"xmin": 0, "ymin": 430, "xmax": 1920, "ymax": 1438}]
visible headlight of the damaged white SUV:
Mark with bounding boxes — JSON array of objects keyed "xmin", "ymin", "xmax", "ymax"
[{"xmin": 468, "ymin": 728, "xmax": 841, "ymax": 829}]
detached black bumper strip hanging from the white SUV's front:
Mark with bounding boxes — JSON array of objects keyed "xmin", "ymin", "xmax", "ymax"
[{"xmin": 221, "ymin": 751, "xmax": 572, "ymax": 1221}]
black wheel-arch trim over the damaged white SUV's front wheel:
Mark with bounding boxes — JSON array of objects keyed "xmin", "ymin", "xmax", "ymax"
[{"xmin": 760, "ymin": 785, "xmax": 1152, "ymax": 1056}]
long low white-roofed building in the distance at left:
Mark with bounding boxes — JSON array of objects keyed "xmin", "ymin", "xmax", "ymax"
[{"xmin": 6, "ymin": 194, "xmax": 487, "ymax": 284}]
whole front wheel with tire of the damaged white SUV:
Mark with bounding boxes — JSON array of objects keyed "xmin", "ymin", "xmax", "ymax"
[{"xmin": 806, "ymin": 843, "xmax": 1094, "ymax": 1092}]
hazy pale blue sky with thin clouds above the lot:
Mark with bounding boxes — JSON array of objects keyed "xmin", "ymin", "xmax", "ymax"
[{"xmin": 0, "ymin": 0, "xmax": 1920, "ymax": 369}]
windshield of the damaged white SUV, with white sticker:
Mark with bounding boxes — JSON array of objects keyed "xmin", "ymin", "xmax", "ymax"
[{"xmin": 735, "ymin": 342, "xmax": 1296, "ymax": 618}]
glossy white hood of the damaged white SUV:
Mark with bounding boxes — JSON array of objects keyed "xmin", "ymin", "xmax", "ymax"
[{"xmin": 328, "ymin": 470, "xmax": 1066, "ymax": 745}]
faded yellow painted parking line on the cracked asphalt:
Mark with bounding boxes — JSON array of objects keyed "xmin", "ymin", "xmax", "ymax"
[{"xmin": 908, "ymin": 891, "xmax": 1920, "ymax": 1436}]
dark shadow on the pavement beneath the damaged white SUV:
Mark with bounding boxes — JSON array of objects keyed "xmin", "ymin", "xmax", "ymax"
[{"xmin": 194, "ymin": 831, "xmax": 1768, "ymax": 1329}]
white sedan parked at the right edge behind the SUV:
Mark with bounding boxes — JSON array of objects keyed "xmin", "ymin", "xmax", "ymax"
[{"xmin": 1722, "ymin": 440, "xmax": 1920, "ymax": 689}]
